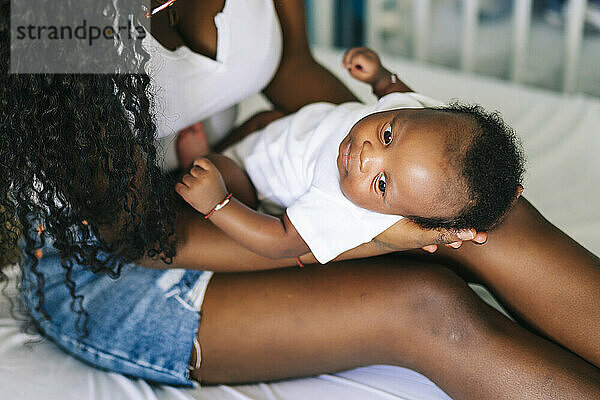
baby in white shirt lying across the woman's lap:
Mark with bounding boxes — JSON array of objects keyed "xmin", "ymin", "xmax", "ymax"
[{"xmin": 176, "ymin": 48, "xmax": 523, "ymax": 263}]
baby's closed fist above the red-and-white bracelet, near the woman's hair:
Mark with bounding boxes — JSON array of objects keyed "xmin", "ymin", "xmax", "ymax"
[{"xmin": 175, "ymin": 158, "xmax": 227, "ymax": 214}]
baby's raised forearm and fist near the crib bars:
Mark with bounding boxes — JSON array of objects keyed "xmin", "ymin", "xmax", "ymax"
[{"xmin": 342, "ymin": 47, "xmax": 412, "ymax": 98}]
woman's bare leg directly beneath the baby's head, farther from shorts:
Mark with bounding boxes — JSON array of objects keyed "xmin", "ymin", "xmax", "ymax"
[{"xmin": 440, "ymin": 198, "xmax": 600, "ymax": 366}]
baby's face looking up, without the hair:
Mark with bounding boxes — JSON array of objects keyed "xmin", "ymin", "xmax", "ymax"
[{"xmin": 337, "ymin": 108, "xmax": 464, "ymax": 218}]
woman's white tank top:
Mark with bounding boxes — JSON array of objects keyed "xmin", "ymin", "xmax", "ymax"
[{"xmin": 143, "ymin": 0, "xmax": 282, "ymax": 142}]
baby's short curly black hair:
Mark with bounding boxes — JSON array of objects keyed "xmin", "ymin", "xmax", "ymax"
[{"xmin": 406, "ymin": 102, "xmax": 525, "ymax": 231}]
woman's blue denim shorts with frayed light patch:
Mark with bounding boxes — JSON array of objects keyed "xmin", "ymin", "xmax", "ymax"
[{"xmin": 22, "ymin": 234, "xmax": 212, "ymax": 386}]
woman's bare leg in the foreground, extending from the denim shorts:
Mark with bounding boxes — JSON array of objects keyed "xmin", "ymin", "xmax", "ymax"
[{"xmin": 192, "ymin": 257, "xmax": 600, "ymax": 400}]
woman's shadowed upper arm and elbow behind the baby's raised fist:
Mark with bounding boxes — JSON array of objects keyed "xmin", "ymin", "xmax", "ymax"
[{"xmin": 263, "ymin": 0, "xmax": 357, "ymax": 113}]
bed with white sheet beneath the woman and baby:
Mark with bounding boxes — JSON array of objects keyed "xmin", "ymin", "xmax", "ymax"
[{"xmin": 0, "ymin": 48, "xmax": 600, "ymax": 400}]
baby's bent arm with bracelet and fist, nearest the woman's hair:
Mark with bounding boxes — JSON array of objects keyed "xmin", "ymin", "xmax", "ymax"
[{"xmin": 175, "ymin": 158, "xmax": 310, "ymax": 258}]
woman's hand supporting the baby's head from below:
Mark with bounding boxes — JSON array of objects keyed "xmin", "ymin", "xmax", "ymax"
[{"xmin": 373, "ymin": 218, "xmax": 487, "ymax": 253}]
